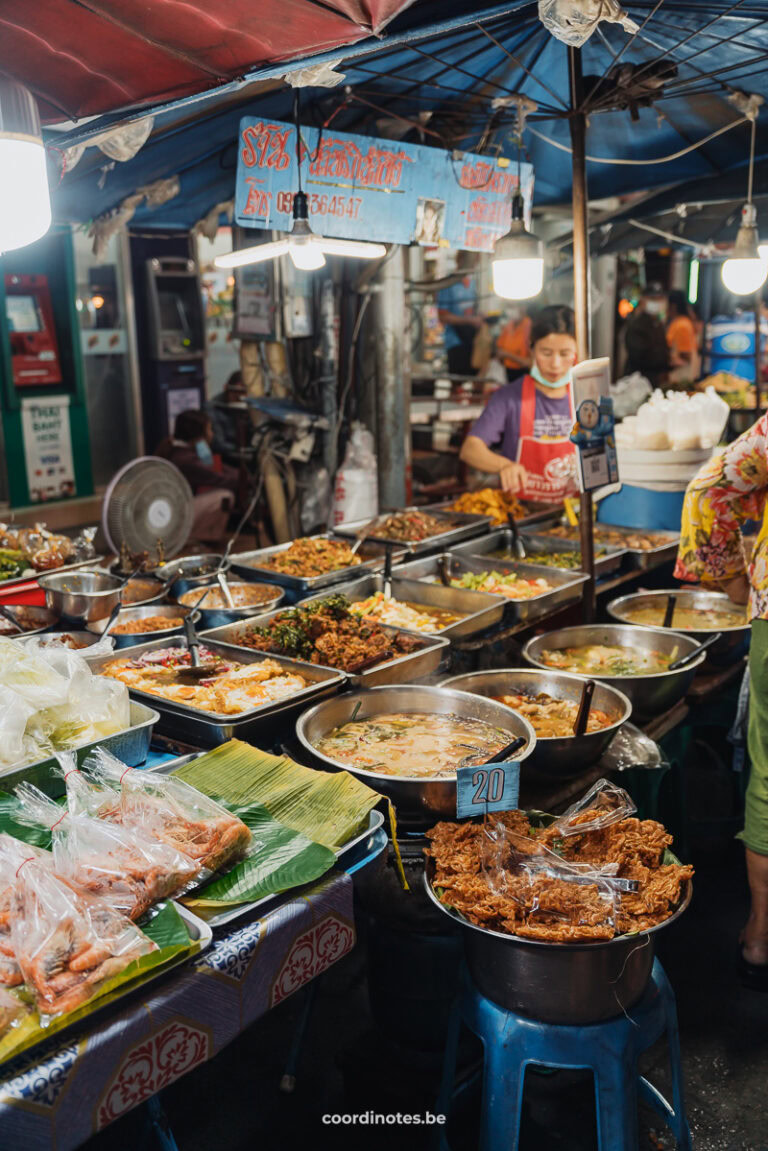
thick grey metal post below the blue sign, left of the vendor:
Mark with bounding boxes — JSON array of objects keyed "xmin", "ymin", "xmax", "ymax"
[{"xmin": 373, "ymin": 247, "xmax": 411, "ymax": 508}]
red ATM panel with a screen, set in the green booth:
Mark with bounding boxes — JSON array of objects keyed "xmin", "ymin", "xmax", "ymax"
[{"xmin": 6, "ymin": 275, "xmax": 61, "ymax": 388}]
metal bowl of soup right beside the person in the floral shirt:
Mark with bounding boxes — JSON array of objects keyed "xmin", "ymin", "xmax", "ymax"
[{"xmin": 608, "ymin": 588, "xmax": 750, "ymax": 665}]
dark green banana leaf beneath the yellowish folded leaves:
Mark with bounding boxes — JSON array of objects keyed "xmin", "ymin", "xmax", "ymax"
[{"xmin": 184, "ymin": 803, "xmax": 336, "ymax": 913}]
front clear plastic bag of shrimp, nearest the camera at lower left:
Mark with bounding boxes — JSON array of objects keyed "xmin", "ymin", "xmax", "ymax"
[{"xmin": 10, "ymin": 860, "xmax": 158, "ymax": 1017}]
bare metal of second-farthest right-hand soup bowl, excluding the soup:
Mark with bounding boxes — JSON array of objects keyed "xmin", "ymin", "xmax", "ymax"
[{"xmin": 523, "ymin": 624, "xmax": 707, "ymax": 719}]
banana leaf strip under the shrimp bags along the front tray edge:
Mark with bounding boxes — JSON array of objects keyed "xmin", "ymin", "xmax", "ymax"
[{"xmin": 0, "ymin": 902, "xmax": 199, "ymax": 1062}]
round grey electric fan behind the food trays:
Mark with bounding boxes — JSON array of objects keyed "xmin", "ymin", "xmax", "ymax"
[{"xmin": 101, "ymin": 456, "xmax": 195, "ymax": 559}]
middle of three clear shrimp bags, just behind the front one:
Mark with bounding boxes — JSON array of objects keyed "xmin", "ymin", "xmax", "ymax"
[{"xmin": 15, "ymin": 783, "xmax": 200, "ymax": 920}]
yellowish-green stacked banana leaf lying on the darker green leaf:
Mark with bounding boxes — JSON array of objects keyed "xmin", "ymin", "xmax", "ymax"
[{"xmin": 175, "ymin": 739, "xmax": 381, "ymax": 851}]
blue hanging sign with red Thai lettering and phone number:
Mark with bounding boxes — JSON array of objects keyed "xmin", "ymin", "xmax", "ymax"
[{"xmin": 235, "ymin": 116, "xmax": 533, "ymax": 252}]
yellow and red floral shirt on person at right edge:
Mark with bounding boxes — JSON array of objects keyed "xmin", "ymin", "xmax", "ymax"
[{"xmin": 675, "ymin": 416, "xmax": 768, "ymax": 619}]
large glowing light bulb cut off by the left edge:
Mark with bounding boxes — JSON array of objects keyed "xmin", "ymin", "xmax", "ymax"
[{"xmin": 0, "ymin": 78, "xmax": 51, "ymax": 252}]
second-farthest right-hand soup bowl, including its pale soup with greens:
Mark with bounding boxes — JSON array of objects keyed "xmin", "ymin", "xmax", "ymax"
[{"xmin": 523, "ymin": 624, "xmax": 707, "ymax": 719}]
